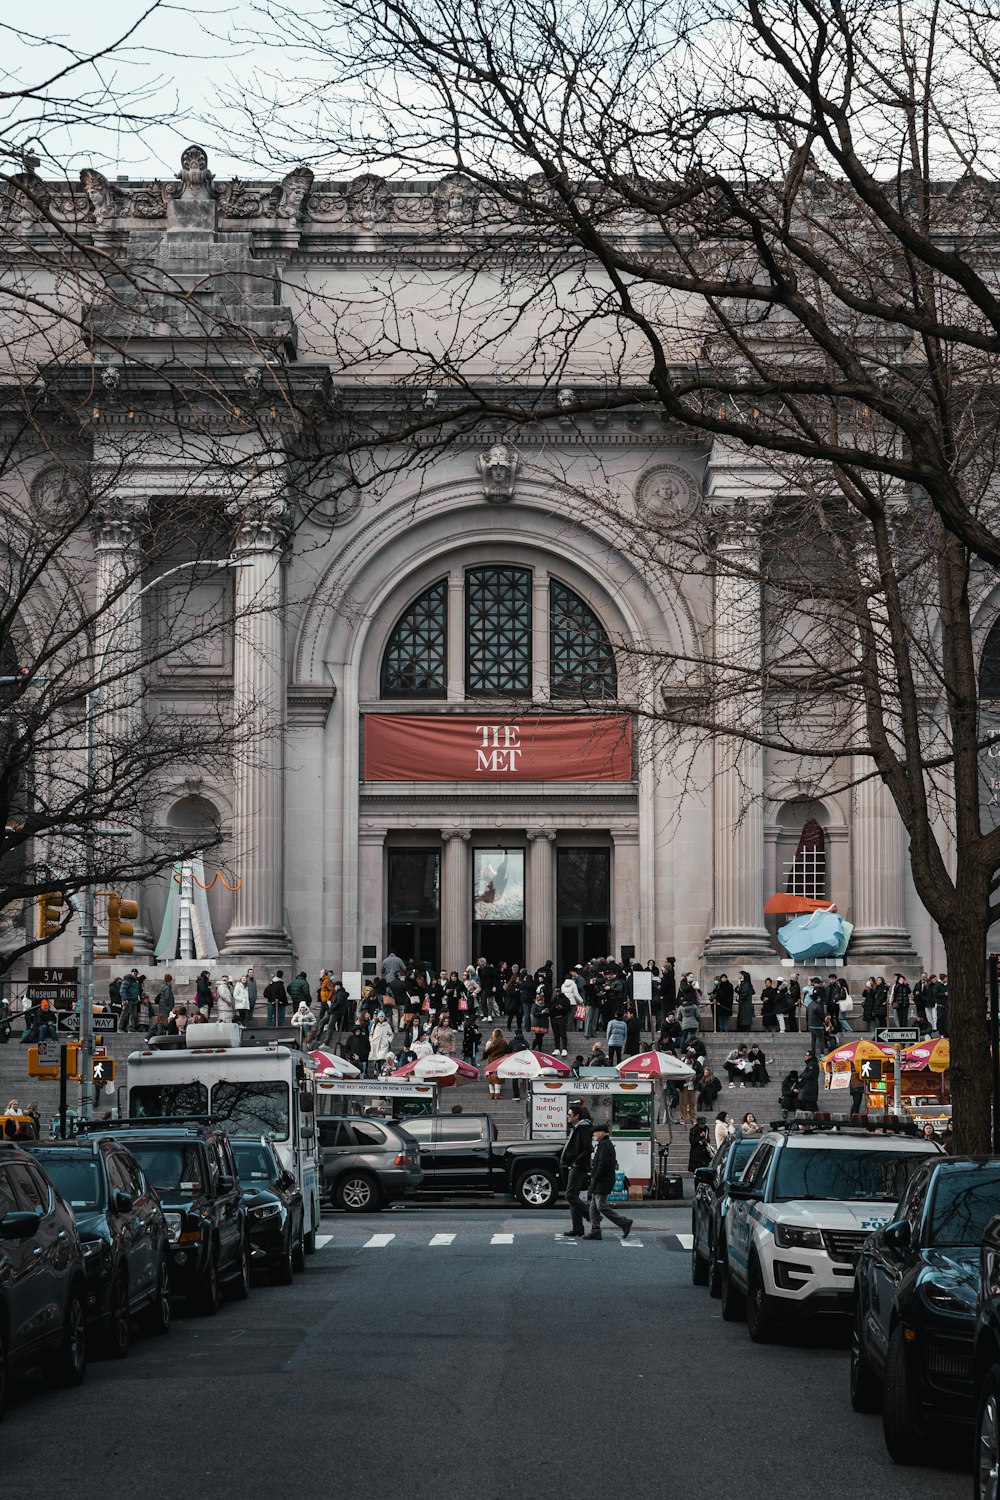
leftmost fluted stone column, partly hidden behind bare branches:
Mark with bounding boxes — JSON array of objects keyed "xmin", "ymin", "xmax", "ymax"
[{"xmin": 94, "ymin": 497, "xmax": 153, "ymax": 957}]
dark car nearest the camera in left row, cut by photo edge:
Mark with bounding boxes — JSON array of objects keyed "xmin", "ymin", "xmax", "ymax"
[{"xmin": 0, "ymin": 1143, "xmax": 87, "ymax": 1416}]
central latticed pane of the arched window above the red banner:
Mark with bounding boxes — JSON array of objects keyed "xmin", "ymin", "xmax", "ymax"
[{"xmin": 465, "ymin": 567, "xmax": 531, "ymax": 698}]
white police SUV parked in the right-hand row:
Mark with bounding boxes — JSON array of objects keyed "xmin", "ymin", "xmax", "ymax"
[{"xmin": 721, "ymin": 1122, "xmax": 939, "ymax": 1344}]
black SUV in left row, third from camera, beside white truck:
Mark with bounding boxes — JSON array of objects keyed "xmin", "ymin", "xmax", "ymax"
[{"xmin": 85, "ymin": 1119, "xmax": 250, "ymax": 1316}]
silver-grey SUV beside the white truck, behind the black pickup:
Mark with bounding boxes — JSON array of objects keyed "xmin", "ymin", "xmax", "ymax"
[{"xmin": 316, "ymin": 1115, "xmax": 423, "ymax": 1214}]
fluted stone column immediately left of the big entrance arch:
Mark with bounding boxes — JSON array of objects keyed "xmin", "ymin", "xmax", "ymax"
[{"xmin": 223, "ymin": 500, "xmax": 291, "ymax": 960}]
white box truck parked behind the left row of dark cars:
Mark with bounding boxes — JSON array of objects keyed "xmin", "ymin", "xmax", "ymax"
[{"xmin": 126, "ymin": 1022, "xmax": 319, "ymax": 1254}]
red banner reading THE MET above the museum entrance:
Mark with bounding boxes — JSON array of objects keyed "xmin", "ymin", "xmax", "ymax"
[{"xmin": 364, "ymin": 714, "xmax": 633, "ymax": 782}]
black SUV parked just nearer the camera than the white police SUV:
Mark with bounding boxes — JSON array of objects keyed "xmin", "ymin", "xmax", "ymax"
[{"xmin": 850, "ymin": 1157, "xmax": 1000, "ymax": 1464}]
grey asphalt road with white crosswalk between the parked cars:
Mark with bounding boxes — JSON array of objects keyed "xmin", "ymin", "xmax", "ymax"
[{"xmin": 0, "ymin": 1208, "xmax": 972, "ymax": 1500}]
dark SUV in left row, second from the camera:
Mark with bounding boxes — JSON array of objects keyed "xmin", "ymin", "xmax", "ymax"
[{"xmin": 27, "ymin": 1136, "xmax": 169, "ymax": 1359}]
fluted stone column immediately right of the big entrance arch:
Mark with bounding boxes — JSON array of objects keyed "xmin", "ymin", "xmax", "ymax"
[{"xmin": 705, "ymin": 501, "xmax": 774, "ymax": 965}]
